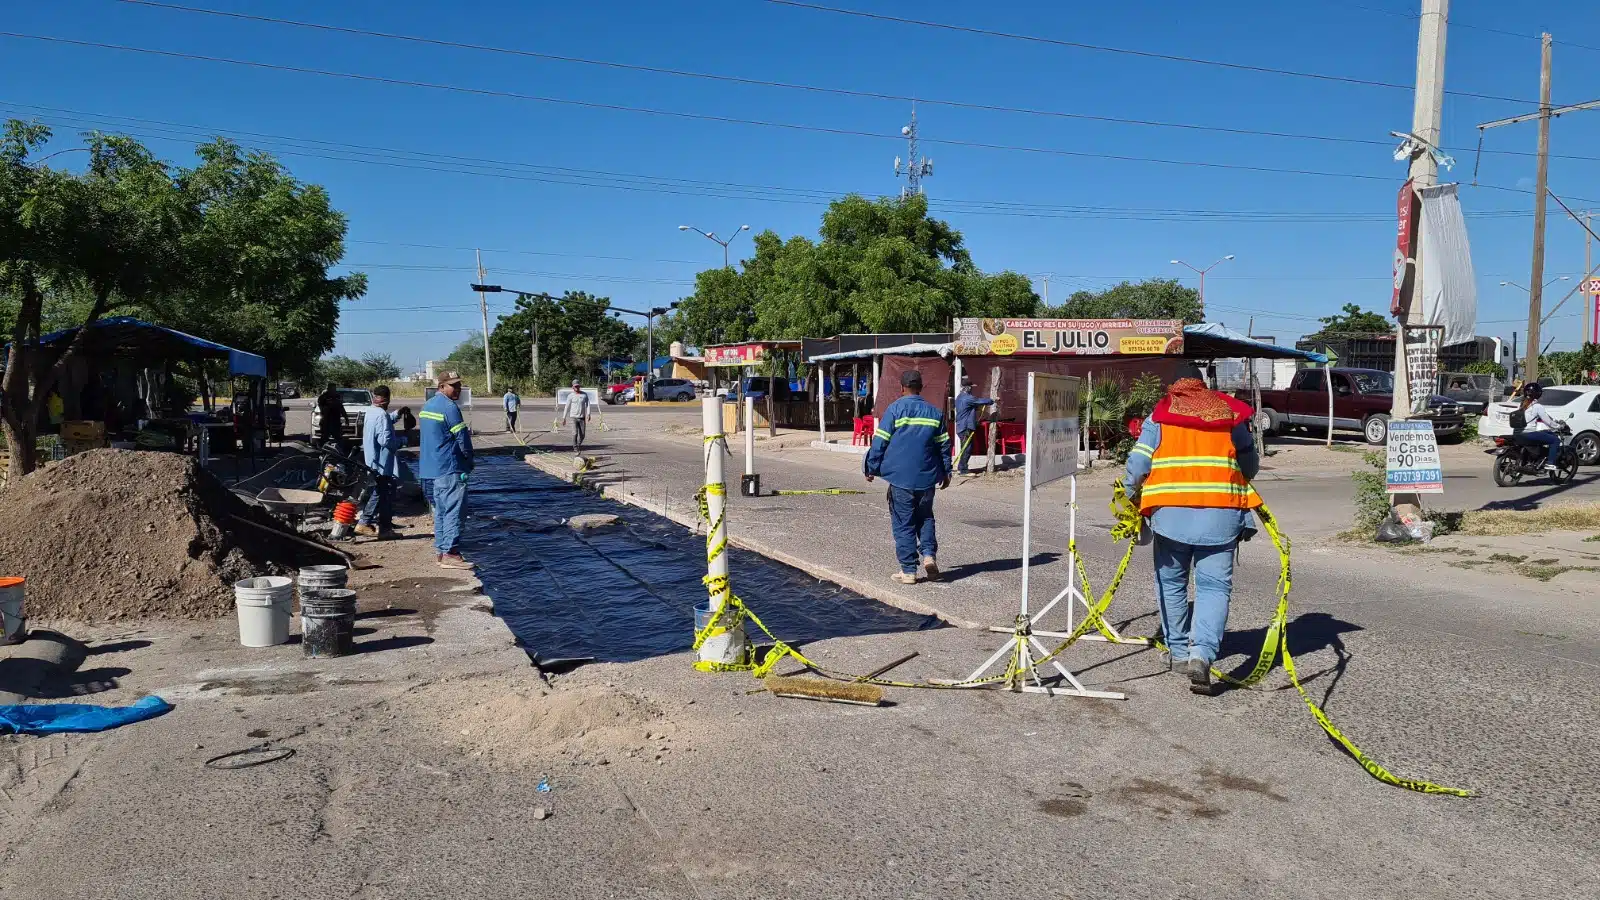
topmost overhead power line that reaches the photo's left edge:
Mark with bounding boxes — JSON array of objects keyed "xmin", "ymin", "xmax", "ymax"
[{"xmin": 0, "ymin": 32, "xmax": 1394, "ymax": 181}]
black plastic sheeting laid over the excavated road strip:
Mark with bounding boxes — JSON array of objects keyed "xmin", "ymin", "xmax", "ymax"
[{"xmin": 462, "ymin": 456, "xmax": 942, "ymax": 663}]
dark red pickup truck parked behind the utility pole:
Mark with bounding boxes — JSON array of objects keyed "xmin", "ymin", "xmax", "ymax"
[{"xmin": 1240, "ymin": 368, "xmax": 1467, "ymax": 444}]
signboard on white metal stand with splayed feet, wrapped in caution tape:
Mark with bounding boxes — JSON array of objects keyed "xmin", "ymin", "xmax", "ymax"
[{"xmin": 947, "ymin": 372, "xmax": 1128, "ymax": 700}]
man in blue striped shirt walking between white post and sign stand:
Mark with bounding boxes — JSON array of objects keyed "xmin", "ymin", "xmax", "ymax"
[{"xmin": 862, "ymin": 368, "xmax": 950, "ymax": 585}]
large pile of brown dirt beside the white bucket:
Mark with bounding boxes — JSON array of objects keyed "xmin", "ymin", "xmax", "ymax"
[{"xmin": 0, "ymin": 450, "xmax": 330, "ymax": 621}]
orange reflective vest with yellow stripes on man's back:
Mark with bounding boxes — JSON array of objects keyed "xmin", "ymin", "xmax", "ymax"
[{"xmin": 1139, "ymin": 424, "xmax": 1261, "ymax": 516}]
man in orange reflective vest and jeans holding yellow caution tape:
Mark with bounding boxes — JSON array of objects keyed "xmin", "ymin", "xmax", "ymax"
[{"xmin": 1125, "ymin": 365, "xmax": 1261, "ymax": 695}]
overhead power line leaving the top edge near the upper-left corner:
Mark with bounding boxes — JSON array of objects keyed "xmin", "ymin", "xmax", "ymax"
[{"xmin": 103, "ymin": 0, "xmax": 1600, "ymax": 162}]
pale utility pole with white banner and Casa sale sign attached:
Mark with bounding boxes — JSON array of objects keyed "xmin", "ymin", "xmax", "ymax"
[{"xmin": 1395, "ymin": 0, "xmax": 1450, "ymax": 519}]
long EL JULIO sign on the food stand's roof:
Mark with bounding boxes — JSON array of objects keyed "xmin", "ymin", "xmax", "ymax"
[{"xmin": 955, "ymin": 319, "xmax": 1184, "ymax": 356}]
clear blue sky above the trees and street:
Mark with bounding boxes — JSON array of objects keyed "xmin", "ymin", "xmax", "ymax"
[{"xmin": 0, "ymin": 0, "xmax": 1600, "ymax": 367}]
